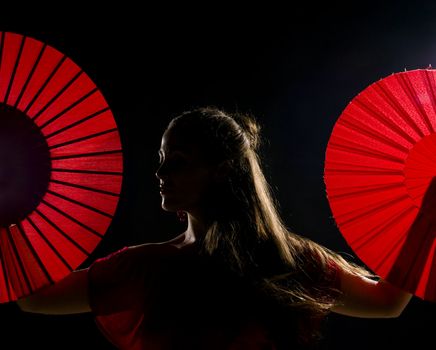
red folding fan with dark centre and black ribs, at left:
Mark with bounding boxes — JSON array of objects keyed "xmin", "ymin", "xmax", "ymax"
[{"xmin": 0, "ymin": 32, "xmax": 123, "ymax": 303}]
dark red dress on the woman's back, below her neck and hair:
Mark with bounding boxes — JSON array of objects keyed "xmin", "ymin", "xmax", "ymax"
[{"xmin": 88, "ymin": 244, "xmax": 276, "ymax": 350}]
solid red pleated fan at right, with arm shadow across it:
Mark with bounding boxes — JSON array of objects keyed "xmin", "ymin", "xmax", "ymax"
[{"xmin": 324, "ymin": 69, "xmax": 436, "ymax": 301}]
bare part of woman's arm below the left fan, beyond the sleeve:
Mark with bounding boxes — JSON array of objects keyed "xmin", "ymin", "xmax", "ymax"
[{"xmin": 17, "ymin": 269, "xmax": 91, "ymax": 315}]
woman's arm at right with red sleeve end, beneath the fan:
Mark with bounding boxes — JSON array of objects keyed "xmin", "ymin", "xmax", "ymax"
[{"xmin": 332, "ymin": 270, "xmax": 413, "ymax": 318}]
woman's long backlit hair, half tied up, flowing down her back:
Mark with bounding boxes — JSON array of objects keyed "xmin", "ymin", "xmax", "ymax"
[{"xmin": 168, "ymin": 107, "xmax": 370, "ymax": 346}]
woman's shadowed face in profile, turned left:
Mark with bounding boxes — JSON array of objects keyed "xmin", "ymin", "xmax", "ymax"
[{"xmin": 156, "ymin": 129, "xmax": 217, "ymax": 213}]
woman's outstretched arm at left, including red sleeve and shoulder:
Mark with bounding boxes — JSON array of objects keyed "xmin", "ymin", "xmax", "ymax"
[{"xmin": 17, "ymin": 243, "xmax": 166, "ymax": 315}]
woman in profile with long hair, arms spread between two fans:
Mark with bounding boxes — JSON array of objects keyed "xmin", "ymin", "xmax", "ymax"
[{"xmin": 18, "ymin": 107, "xmax": 411, "ymax": 349}]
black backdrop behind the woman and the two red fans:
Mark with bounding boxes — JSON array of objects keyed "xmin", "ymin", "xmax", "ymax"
[{"xmin": 0, "ymin": 1, "xmax": 436, "ymax": 349}]
